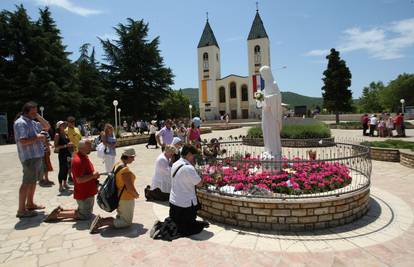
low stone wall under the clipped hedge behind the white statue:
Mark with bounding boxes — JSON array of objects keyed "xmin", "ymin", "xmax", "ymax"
[{"xmin": 243, "ymin": 137, "xmax": 335, "ymax": 147}]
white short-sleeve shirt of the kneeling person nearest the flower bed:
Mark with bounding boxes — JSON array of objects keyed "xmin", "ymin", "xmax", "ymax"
[{"xmin": 170, "ymin": 158, "xmax": 201, "ymax": 208}]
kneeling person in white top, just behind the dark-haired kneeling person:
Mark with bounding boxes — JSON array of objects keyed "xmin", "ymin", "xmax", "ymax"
[{"xmin": 145, "ymin": 146, "xmax": 179, "ymax": 201}]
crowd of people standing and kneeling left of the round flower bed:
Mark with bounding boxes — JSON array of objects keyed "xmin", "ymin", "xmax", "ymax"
[{"xmin": 14, "ymin": 102, "xmax": 208, "ymax": 240}]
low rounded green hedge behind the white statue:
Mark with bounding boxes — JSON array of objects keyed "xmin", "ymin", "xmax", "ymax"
[{"xmin": 247, "ymin": 122, "xmax": 331, "ymax": 139}]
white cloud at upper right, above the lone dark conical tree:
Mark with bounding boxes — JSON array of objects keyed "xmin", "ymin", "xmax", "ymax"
[{"xmin": 306, "ymin": 18, "xmax": 414, "ymax": 60}]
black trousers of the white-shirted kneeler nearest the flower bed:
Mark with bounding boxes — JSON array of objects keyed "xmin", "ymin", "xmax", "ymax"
[{"xmin": 170, "ymin": 202, "xmax": 206, "ymax": 236}]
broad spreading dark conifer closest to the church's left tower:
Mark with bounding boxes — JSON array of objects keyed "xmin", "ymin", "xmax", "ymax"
[{"xmin": 100, "ymin": 18, "xmax": 173, "ymax": 118}]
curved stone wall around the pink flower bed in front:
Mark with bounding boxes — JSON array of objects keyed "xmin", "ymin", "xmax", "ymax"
[{"xmin": 197, "ymin": 188, "xmax": 370, "ymax": 231}]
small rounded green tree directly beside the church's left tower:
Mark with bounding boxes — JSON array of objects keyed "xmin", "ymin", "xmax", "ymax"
[{"xmin": 159, "ymin": 90, "xmax": 191, "ymax": 118}]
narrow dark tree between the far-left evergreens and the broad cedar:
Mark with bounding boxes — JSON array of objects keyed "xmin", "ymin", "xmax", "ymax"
[{"xmin": 75, "ymin": 44, "xmax": 110, "ymax": 125}]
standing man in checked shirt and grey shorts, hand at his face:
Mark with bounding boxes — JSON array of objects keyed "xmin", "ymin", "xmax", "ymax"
[{"xmin": 13, "ymin": 102, "xmax": 50, "ymax": 218}]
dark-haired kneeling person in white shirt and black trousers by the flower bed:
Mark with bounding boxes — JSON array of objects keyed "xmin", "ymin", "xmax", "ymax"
[{"xmin": 170, "ymin": 144, "xmax": 208, "ymax": 236}]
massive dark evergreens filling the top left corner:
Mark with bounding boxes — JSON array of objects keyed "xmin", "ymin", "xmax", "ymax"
[{"xmin": 0, "ymin": 5, "xmax": 80, "ymax": 127}]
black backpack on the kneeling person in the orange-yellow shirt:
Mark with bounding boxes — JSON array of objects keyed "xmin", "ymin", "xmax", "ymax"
[{"xmin": 96, "ymin": 165, "xmax": 125, "ymax": 212}]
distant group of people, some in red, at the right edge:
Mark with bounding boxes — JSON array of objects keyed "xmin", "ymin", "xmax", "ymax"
[{"xmin": 361, "ymin": 112, "xmax": 405, "ymax": 137}]
